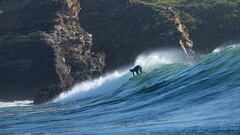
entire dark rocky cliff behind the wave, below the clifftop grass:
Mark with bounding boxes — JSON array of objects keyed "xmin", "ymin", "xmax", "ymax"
[{"xmin": 0, "ymin": 0, "xmax": 240, "ymax": 103}]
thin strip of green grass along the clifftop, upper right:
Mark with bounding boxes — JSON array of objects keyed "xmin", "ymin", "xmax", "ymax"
[{"xmin": 139, "ymin": 0, "xmax": 240, "ymax": 6}]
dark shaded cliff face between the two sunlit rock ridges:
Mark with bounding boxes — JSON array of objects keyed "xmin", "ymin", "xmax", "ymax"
[{"xmin": 80, "ymin": 0, "xmax": 181, "ymax": 71}]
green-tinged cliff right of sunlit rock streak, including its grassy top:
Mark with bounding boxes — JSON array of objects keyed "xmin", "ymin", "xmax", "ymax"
[{"xmin": 135, "ymin": 0, "xmax": 240, "ymax": 52}]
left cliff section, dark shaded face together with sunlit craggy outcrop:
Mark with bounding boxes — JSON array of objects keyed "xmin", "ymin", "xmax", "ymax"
[{"xmin": 0, "ymin": 0, "xmax": 104, "ymax": 103}]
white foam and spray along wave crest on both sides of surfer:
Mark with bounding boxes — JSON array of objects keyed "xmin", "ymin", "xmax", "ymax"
[{"xmin": 53, "ymin": 50, "xmax": 184, "ymax": 102}]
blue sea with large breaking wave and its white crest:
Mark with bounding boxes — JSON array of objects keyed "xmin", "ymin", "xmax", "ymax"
[{"xmin": 0, "ymin": 45, "xmax": 240, "ymax": 135}]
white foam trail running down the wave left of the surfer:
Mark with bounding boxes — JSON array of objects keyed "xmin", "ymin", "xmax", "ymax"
[{"xmin": 54, "ymin": 71, "xmax": 131, "ymax": 102}]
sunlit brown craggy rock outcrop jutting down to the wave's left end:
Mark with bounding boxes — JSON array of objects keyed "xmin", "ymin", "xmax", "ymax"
[{"xmin": 35, "ymin": 0, "xmax": 105, "ymax": 103}]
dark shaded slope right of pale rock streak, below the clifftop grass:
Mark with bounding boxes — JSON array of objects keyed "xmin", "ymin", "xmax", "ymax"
[{"xmin": 176, "ymin": 3, "xmax": 240, "ymax": 53}]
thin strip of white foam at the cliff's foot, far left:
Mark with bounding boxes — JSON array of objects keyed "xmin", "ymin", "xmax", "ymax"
[{"xmin": 0, "ymin": 100, "xmax": 33, "ymax": 108}]
